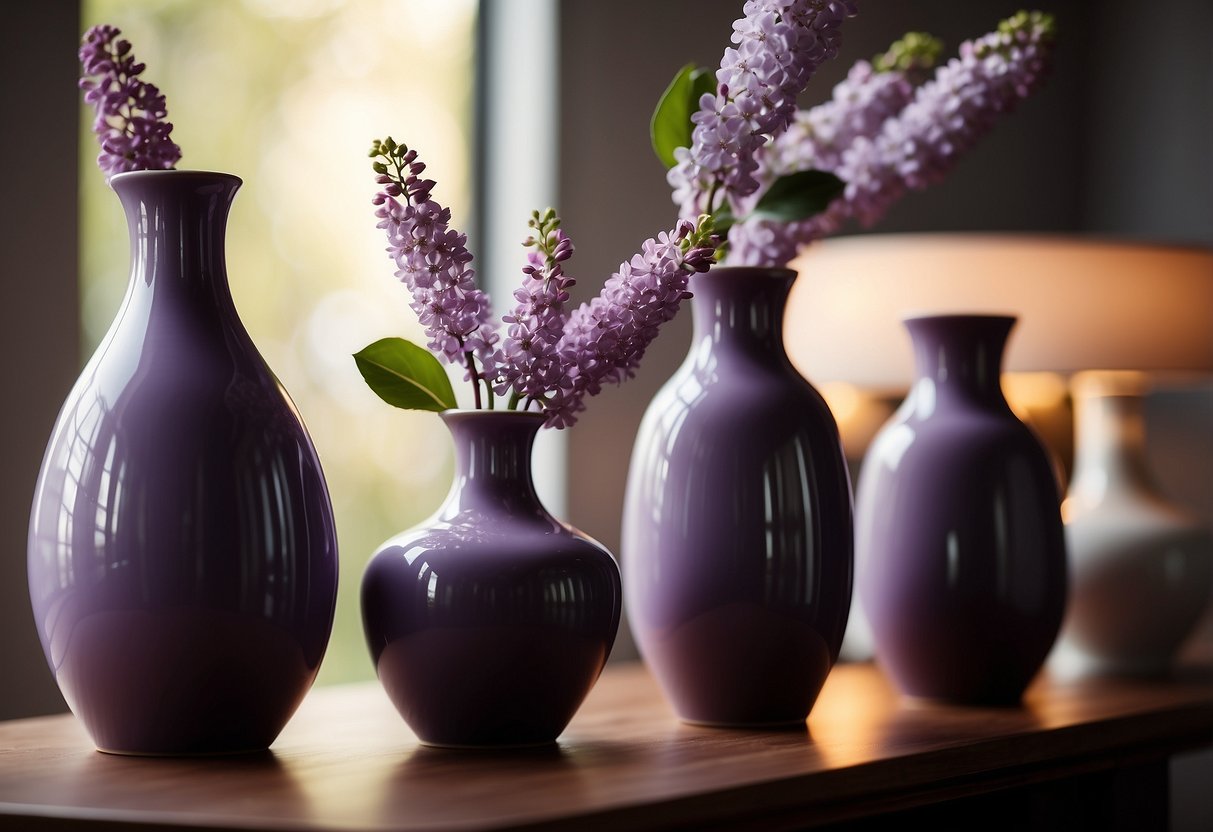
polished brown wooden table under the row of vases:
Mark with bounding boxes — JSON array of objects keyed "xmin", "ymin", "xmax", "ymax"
[{"xmin": 0, "ymin": 663, "xmax": 1213, "ymax": 831}]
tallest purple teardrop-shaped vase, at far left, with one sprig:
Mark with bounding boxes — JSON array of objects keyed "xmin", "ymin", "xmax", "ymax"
[{"xmin": 28, "ymin": 171, "xmax": 337, "ymax": 754}]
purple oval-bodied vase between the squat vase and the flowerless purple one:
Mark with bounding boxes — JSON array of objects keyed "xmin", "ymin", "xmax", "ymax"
[{"xmin": 622, "ymin": 267, "xmax": 853, "ymax": 726}]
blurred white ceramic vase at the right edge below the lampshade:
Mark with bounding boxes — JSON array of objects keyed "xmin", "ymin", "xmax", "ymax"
[{"xmin": 1049, "ymin": 374, "xmax": 1213, "ymax": 676}]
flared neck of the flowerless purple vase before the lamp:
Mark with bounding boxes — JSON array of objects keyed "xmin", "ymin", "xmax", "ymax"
[{"xmin": 905, "ymin": 315, "xmax": 1015, "ymax": 406}]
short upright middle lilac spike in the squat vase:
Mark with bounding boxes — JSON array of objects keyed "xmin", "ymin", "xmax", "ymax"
[{"xmin": 496, "ymin": 217, "xmax": 575, "ymax": 406}]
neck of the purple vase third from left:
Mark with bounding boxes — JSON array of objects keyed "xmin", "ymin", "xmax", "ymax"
[{"xmin": 690, "ymin": 267, "xmax": 796, "ymax": 360}]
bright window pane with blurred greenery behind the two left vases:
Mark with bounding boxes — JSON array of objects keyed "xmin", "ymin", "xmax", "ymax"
[{"xmin": 80, "ymin": 0, "xmax": 477, "ymax": 683}]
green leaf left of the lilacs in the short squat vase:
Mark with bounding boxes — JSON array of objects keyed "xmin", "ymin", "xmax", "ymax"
[{"xmin": 354, "ymin": 338, "xmax": 457, "ymax": 411}]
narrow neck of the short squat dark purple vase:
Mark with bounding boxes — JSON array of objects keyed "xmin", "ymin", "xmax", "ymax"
[{"xmin": 442, "ymin": 410, "xmax": 543, "ymax": 511}]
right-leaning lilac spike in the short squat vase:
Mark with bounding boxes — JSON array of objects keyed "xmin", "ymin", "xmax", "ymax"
[{"xmin": 546, "ymin": 217, "xmax": 719, "ymax": 427}]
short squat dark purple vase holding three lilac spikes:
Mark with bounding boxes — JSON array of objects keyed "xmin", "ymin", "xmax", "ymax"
[{"xmin": 361, "ymin": 410, "xmax": 622, "ymax": 747}]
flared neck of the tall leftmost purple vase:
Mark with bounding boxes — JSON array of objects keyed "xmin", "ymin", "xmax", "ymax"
[{"xmin": 112, "ymin": 171, "xmax": 240, "ymax": 303}]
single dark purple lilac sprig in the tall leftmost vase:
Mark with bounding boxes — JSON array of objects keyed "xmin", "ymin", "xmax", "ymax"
[{"xmin": 80, "ymin": 24, "xmax": 181, "ymax": 181}]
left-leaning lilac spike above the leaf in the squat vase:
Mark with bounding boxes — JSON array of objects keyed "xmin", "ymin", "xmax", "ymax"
[{"xmin": 371, "ymin": 138, "xmax": 500, "ymax": 399}]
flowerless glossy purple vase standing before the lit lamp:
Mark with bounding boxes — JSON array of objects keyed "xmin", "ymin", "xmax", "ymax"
[{"xmin": 855, "ymin": 315, "xmax": 1066, "ymax": 705}]
